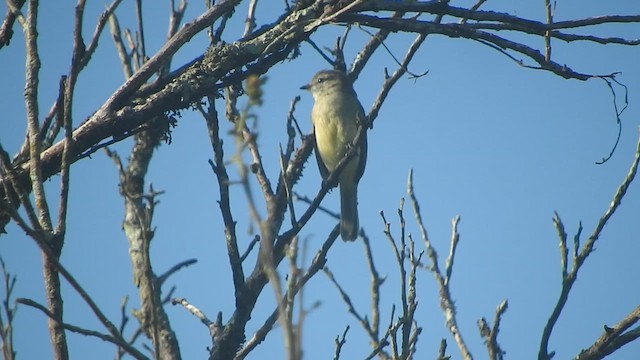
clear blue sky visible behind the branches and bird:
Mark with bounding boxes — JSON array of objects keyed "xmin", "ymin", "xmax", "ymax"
[{"xmin": 0, "ymin": 0, "xmax": 640, "ymax": 359}]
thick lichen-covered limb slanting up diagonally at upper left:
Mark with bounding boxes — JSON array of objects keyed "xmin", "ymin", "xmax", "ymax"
[{"xmin": 0, "ymin": 0, "xmax": 330, "ymax": 233}]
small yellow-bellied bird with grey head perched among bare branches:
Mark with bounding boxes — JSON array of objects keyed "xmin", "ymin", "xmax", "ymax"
[{"xmin": 301, "ymin": 70, "xmax": 367, "ymax": 241}]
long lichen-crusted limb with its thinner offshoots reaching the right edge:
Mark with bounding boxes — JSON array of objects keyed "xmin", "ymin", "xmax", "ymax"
[{"xmin": 3, "ymin": 0, "xmax": 640, "ymax": 236}]
